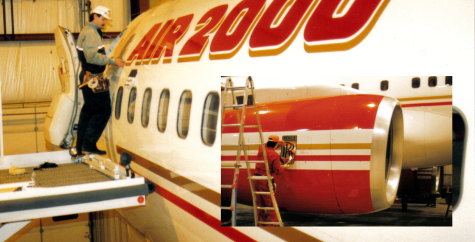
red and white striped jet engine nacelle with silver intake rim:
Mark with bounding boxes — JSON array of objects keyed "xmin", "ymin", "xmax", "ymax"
[{"xmin": 221, "ymin": 94, "xmax": 403, "ymax": 214}]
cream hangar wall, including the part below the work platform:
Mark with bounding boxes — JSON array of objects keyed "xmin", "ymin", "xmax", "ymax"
[{"xmin": 0, "ymin": 0, "xmax": 152, "ymax": 242}]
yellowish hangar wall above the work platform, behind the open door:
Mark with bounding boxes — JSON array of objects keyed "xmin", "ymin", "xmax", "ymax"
[{"xmin": 0, "ymin": 0, "xmax": 130, "ymax": 155}]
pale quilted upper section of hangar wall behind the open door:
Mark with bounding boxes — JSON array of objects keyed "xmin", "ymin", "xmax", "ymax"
[{"xmin": 0, "ymin": 0, "xmax": 130, "ymax": 103}]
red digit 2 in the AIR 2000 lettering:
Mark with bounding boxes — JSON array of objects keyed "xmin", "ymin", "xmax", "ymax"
[{"xmin": 179, "ymin": 4, "xmax": 228, "ymax": 61}]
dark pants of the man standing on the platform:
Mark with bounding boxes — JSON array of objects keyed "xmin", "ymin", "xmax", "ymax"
[{"xmin": 76, "ymin": 71, "xmax": 112, "ymax": 152}]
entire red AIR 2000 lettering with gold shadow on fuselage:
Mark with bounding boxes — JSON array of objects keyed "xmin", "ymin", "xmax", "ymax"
[{"xmin": 127, "ymin": 0, "xmax": 389, "ymax": 65}]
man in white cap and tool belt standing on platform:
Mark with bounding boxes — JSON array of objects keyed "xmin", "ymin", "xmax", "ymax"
[{"xmin": 76, "ymin": 6, "xmax": 125, "ymax": 156}]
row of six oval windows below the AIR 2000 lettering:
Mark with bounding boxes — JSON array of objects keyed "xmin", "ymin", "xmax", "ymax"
[{"xmin": 115, "ymin": 86, "xmax": 220, "ymax": 146}]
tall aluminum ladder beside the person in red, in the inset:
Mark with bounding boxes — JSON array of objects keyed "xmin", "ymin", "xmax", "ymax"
[{"xmin": 221, "ymin": 77, "xmax": 283, "ymax": 227}]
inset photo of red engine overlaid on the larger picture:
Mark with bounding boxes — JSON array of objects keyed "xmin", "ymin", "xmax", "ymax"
[{"xmin": 221, "ymin": 76, "xmax": 458, "ymax": 227}]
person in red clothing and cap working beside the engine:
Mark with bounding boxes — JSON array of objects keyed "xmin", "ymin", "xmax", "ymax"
[{"xmin": 255, "ymin": 135, "xmax": 289, "ymax": 226}]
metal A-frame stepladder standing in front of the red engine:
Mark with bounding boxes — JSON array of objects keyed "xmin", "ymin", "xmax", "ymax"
[{"xmin": 221, "ymin": 77, "xmax": 283, "ymax": 227}]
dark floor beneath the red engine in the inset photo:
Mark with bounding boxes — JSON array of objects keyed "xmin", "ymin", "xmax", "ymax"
[{"xmin": 221, "ymin": 199, "xmax": 452, "ymax": 226}]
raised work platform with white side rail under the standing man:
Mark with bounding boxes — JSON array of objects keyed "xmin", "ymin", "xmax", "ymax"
[{"xmin": 0, "ymin": 151, "xmax": 154, "ymax": 224}]
